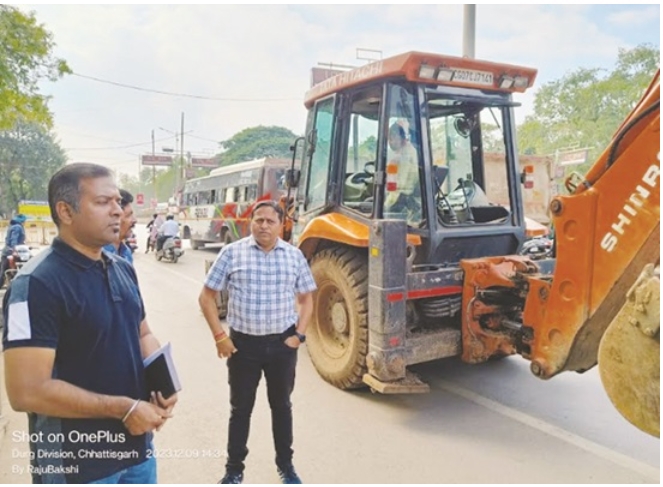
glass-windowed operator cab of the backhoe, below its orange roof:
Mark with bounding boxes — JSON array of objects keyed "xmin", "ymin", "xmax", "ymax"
[{"xmin": 295, "ymin": 53, "xmax": 536, "ymax": 266}]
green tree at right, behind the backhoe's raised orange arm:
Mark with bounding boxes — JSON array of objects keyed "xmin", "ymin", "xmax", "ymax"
[{"xmin": 518, "ymin": 45, "xmax": 660, "ymax": 172}]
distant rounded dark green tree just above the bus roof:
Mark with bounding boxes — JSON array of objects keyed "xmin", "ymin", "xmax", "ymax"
[{"xmin": 219, "ymin": 125, "xmax": 297, "ymax": 166}]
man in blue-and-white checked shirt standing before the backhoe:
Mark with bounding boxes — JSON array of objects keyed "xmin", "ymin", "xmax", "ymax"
[{"xmin": 198, "ymin": 201, "xmax": 316, "ymax": 484}]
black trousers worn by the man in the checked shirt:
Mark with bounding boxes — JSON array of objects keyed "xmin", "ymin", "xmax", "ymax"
[{"xmin": 226, "ymin": 326, "xmax": 297, "ymax": 473}]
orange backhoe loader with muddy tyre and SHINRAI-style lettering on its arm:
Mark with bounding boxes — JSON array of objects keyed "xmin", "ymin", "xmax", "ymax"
[{"xmin": 244, "ymin": 52, "xmax": 660, "ymax": 436}]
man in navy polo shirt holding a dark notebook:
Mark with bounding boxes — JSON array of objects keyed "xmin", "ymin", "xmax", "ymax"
[{"xmin": 3, "ymin": 163, "xmax": 177, "ymax": 483}]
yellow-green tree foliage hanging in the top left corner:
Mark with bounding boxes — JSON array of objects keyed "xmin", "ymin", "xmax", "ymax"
[{"xmin": 0, "ymin": 5, "xmax": 72, "ymax": 130}]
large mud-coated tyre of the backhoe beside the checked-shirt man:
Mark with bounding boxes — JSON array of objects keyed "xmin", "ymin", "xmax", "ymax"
[{"xmin": 306, "ymin": 248, "xmax": 368, "ymax": 389}]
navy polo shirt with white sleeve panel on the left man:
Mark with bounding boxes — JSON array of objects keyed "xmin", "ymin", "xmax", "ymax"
[{"xmin": 3, "ymin": 238, "xmax": 148, "ymax": 483}]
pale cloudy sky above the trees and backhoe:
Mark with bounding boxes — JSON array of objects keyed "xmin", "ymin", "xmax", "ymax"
[{"xmin": 13, "ymin": 3, "xmax": 660, "ymax": 175}]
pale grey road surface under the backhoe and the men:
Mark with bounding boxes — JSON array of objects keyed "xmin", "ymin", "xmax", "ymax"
[{"xmin": 0, "ymin": 227, "xmax": 660, "ymax": 484}]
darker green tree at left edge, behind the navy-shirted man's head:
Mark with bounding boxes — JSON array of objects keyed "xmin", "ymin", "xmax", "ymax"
[{"xmin": 0, "ymin": 122, "xmax": 67, "ymax": 214}]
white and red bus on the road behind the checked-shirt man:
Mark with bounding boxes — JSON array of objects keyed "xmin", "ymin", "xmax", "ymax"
[{"xmin": 179, "ymin": 157, "xmax": 292, "ymax": 250}]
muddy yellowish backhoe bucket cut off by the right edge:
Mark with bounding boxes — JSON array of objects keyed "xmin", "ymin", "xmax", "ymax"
[{"xmin": 598, "ymin": 264, "xmax": 661, "ymax": 437}]
